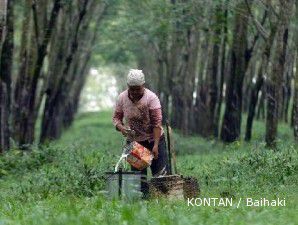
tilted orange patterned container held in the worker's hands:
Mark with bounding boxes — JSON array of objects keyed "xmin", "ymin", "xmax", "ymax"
[{"xmin": 126, "ymin": 141, "xmax": 153, "ymax": 170}]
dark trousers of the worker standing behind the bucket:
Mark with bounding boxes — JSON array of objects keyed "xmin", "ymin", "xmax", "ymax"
[{"xmin": 131, "ymin": 135, "xmax": 169, "ymax": 194}]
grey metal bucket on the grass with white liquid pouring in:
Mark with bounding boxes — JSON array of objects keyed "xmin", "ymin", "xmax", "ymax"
[{"xmin": 106, "ymin": 170, "xmax": 142, "ymax": 200}]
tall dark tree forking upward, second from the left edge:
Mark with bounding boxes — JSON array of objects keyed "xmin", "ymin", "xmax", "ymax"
[{"xmin": 13, "ymin": 0, "xmax": 61, "ymax": 147}]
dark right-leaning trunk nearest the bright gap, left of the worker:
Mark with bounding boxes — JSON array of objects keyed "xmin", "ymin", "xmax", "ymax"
[{"xmin": 40, "ymin": 0, "xmax": 107, "ymax": 142}]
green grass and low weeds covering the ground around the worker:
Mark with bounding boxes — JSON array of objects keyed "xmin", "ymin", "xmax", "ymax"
[{"xmin": 0, "ymin": 112, "xmax": 298, "ymax": 225}]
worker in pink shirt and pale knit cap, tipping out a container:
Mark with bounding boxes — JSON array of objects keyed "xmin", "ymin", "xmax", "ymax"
[{"xmin": 113, "ymin": 69, "xmax": 168, "ymax": 180}]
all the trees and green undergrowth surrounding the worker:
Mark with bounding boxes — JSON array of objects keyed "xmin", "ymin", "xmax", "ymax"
[{"xmin": 0, "ymin": 0, "xmax": 298, "ymax": 224}]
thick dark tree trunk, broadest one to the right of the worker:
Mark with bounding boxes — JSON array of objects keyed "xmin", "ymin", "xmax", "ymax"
[{"xmin": 221, "ymin": 2, "xmax": 250, "ymax": 142}]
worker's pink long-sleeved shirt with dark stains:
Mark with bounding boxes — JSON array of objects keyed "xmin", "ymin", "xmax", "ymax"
[{"xmin": 113, "ymin": 88, "xmax": 163, "ymax": 141}]
